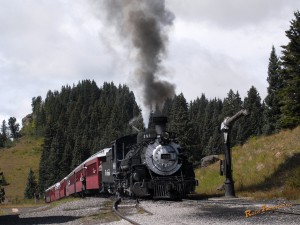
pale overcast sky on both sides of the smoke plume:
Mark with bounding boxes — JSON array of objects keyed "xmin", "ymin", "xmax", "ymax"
[{"xmin": 0, "ymin": 0, "xmax": 300, "ymax": 124}]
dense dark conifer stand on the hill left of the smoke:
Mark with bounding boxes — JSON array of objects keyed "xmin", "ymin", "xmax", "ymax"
[{"xmin": 25, "ymin": 80, "xmax": 142, "ymax": 192}]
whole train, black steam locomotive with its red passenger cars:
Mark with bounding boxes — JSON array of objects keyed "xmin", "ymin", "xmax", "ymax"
[{"xmin": 45, "ymin": 115, "xmax": 198, "ymax": 202}]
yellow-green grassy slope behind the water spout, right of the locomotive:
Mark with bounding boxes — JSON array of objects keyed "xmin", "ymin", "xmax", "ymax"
[{"xmin": 196, "ymin": 127, "xmax": 300, "ymax": 199}]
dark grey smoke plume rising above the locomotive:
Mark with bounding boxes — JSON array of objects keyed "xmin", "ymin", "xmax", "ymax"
[{"xmin": 102, "ymin": 0, "xmax": 175, "ymax": 109}]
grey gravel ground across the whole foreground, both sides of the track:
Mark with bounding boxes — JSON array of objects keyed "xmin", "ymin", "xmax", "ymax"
[{"xmin": 0, "ymin": 198, "xmax": 300, "ymax": 225}]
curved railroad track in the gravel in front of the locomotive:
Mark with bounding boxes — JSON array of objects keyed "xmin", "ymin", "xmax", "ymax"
[{"xmin": 113, "ymin": 198, "xmax": 153, "ymax": 225}]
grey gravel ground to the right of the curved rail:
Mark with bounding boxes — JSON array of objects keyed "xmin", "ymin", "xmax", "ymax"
[{"xmin": 110, "ymin": 199, "xmax": 300, "ymax": 225}]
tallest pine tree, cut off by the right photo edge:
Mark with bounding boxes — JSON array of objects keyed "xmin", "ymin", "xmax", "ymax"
[{"xmin": 279, "ymin": 11, "xmax": 300, "ymax": 128}]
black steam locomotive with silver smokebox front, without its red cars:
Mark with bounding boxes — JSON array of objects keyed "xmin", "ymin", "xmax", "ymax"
[{"xmin": 102, "ymin": 115, "xmax": 198, "ymax": 199}]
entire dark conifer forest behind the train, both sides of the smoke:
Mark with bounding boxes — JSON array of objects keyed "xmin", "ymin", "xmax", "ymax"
[{"xmin": 18, "ymin": 11, "xmax": 300, "ymax": 193}]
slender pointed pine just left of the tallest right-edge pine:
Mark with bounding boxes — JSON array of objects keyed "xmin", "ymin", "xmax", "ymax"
[{"xmin": 262, "ymin": 46, "xmax": 282, "ymax": 134}]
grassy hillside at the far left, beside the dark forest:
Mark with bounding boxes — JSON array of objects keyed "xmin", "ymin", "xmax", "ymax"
[{"xmin": 0, "ymin": 137, "xmax": 43, "ymax": 203}]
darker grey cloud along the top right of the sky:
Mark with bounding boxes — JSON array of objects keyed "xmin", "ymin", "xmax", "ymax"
[{"xmin": 167, "ymin": 0, "xmax": 299, "ymax": 29}]
